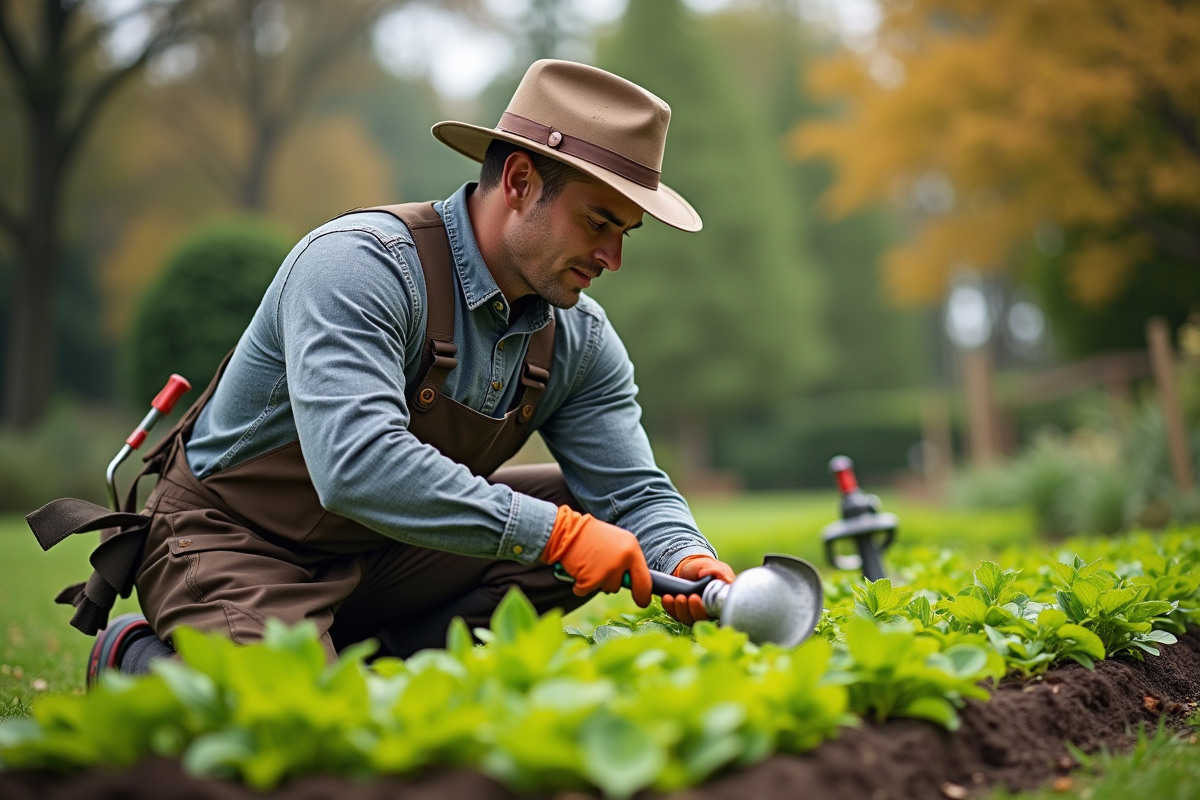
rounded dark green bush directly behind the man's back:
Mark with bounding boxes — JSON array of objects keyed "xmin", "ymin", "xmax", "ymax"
[{"xmin": 125, "ymin": 218, "xmax": 290, "ymax": 409}]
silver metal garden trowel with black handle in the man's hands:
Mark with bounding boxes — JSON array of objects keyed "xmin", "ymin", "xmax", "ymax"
[{"xmin": 554, "ymin": 554, "xmax": 824, "ymax": 648}]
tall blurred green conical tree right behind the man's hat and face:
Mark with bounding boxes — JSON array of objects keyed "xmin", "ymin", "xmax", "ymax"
[{"xmin": 594, "ymin": 0, "xmax": 829, "ymax": 471}]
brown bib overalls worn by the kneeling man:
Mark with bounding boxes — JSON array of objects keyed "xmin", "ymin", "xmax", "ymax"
[{"xmin": 29, "ymin": 204, "xmax": 584, "ymax": 658}]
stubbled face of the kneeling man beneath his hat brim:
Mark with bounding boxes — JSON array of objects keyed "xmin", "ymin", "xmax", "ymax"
[{"xmin": 508, "ymin": 181, "xmax": 642, "ymax": 308}]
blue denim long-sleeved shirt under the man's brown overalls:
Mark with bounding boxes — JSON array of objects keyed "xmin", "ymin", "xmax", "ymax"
[{"xmin": 186, "ymin": 184, "xmax": 714, "ymax": 572}]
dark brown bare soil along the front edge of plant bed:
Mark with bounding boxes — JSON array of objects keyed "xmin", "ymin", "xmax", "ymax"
[{"xmin": 0, "ymin": 632, "xmax": 1200, "ymax": 800}]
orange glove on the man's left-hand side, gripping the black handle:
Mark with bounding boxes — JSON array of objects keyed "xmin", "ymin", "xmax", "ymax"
[{"xmin": 541, "ymin": 506, "xmax": 650, "ymax": 608}]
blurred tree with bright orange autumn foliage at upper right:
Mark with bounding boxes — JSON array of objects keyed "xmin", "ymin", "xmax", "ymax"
[{"xmin": 794, "ymin": 0, "xmax": 1200, "ymax": 352}]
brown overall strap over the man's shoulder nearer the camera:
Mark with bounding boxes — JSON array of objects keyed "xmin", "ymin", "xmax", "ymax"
[{"xmin": 360, "ymin": 203, "xmax": 458, "ymax": 411}]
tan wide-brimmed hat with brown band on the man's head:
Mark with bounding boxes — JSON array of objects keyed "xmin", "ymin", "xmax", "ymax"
[{"xmin": 433, "ymin": 59, "xmax": 702, "ymax": 230}]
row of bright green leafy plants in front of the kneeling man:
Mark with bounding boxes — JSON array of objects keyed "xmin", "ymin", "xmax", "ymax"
[{"xmin": 0, "ymin": 527, "xmax": 1200, "ymax": 798}]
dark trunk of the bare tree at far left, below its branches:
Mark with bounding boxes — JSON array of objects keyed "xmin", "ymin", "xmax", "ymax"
[{"xmin": 4, "ymin": 102, "xmax": 65, "ymax": 431}]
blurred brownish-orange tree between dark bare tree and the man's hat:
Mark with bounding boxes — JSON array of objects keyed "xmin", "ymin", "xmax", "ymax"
[{"xmin": 89, "ymin": 0, "xmax": 420, "ymax": 347}]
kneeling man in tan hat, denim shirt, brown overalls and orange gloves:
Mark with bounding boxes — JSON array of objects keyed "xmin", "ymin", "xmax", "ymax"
[{"xmin": 40, "ymin": 60, "xmax": 733, "ymax": 680}]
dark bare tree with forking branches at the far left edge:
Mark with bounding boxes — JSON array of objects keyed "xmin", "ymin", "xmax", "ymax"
[{"xmin": 0, "ymin": 0, "xmax": 196, "ymax": 429}]
